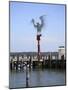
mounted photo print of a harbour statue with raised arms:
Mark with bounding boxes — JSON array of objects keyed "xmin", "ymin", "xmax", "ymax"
[{"xmin": 9, "ymin": 1, "xmax": 66, "ymax": 89}]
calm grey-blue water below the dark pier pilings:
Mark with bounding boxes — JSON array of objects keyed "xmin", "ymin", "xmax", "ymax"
[{"xmin": 9, "ymin": 69, "xmax": 65, "ymax": 88}]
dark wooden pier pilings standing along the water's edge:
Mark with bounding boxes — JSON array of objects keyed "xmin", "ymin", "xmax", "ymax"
[{"xmin": 10, "ymin": 58, "xmax": 66, "ymax": 70}]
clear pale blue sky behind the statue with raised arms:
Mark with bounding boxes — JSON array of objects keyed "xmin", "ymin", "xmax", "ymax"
[{"xmin": 10, "ymin": 2, "xmax": 65, "ymax": 52}]
